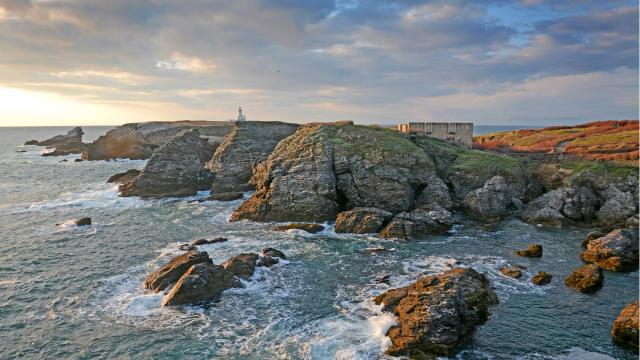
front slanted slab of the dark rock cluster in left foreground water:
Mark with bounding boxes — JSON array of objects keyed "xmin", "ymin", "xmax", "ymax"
[{"xmin": 162, "ymin": 263, "xmax": 242, "ymax": 306}]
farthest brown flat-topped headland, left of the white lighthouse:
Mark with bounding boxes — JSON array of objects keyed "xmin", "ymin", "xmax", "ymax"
[{"xmin": 82, "ymin": 121, "xmax": 232, "ymax": 160}]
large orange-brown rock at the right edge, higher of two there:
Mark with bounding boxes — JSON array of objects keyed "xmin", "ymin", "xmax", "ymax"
[{"xmin": 580, "ymin": 228, "xmax": 638, "ymax": 271}]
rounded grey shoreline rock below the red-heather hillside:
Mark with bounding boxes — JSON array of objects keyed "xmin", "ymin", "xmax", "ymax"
[{"xmin": 521, "ymin": 187, "xmax": 598, "ymax": 227}]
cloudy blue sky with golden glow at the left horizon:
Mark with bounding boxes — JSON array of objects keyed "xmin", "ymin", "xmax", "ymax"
[{"xmin": 0, "ymin": 0, "xmax": 639, "ymax": 126}]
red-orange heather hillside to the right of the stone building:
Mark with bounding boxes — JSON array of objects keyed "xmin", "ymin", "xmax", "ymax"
[{"xmin": 473, "ymin": 120, "xmax": 639, "ymax": 166}]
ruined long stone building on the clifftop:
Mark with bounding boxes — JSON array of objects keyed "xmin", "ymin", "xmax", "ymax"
[{"xmin": 397, "ymin": 122, "xmax": 473, "ymax": 148}]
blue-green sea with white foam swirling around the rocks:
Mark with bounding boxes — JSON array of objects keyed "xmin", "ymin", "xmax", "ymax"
[{"xmin": 0, "ymin": 128, "xmax": 638, "ymax": 360}]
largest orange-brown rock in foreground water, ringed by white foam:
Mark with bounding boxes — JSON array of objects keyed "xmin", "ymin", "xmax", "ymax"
[{"xmin": 374, "ymin": 268, "xmax": 498, "ymax": 358}]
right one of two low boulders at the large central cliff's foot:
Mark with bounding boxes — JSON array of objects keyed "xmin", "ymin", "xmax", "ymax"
[{"xmin": 379, "ymin": 209, "xmax": 453, "ymax": 240}]
